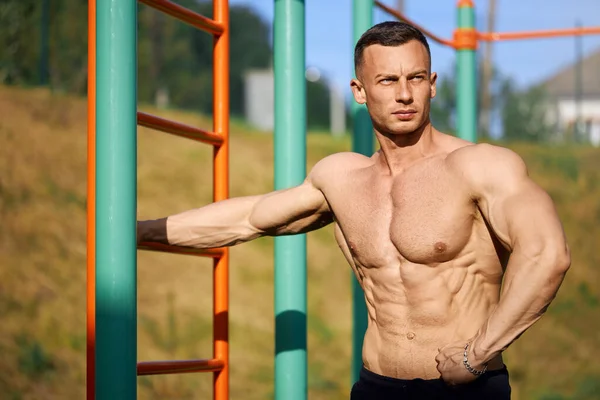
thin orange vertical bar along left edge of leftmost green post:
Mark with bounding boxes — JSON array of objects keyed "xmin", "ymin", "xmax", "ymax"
[{"xmin": 86, "ymin": 0, "xmax": 96, "ymax": 400}]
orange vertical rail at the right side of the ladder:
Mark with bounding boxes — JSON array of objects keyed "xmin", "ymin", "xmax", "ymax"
[{"xmin": 213, "ymin": 0, "xmax": 229, "ymax": 400}]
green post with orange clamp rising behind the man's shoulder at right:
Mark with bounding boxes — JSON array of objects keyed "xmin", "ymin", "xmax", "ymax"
[{"xmin": 456, "ymin": 1, "xmax": 477, "ymax": 143}]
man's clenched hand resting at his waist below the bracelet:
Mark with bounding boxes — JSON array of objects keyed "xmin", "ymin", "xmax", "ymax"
[{"xmin": 435, "ymin": 342, "xmax": 484, "ymax": 386}]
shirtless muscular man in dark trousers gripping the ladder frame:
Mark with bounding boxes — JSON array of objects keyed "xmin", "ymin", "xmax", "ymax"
[{"xmin": 138, "ymin": 22, "xmax": 570, "ymax": 400}]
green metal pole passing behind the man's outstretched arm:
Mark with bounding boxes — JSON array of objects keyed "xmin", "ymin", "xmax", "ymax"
[{"xmin": 274, "ymin": 0, "xmax": 308, "ymax": 400}]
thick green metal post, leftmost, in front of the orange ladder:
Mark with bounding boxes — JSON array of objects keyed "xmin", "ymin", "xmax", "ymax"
[{"xmin": 96, "ymin": 0, "xmax": 137, "ymax": 400}]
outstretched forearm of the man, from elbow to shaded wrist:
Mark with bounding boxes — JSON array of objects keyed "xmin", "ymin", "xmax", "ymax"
[{"xmin": 137, "ymin": 196, "xmax": 261, "ymax": 249}]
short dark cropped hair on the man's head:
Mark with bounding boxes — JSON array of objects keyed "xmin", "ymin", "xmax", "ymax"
[{"xmin": 354, "ymin": 21, "xmax": 431, "ymax": 73}]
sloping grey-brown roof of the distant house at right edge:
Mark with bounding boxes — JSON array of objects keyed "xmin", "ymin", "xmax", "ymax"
[{"xmin": 542, "ymin": 49, "xmax": 600, "ymax": 97}]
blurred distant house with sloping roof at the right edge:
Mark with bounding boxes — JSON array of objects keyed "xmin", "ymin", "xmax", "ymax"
[{"xmin": 542, "ymin": 50, "xmax": 600, "ymax": 146}]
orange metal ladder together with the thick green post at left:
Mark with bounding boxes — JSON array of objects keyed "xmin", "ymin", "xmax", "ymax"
[{"xmin": 87, "ymin": 0, "xmax": 229, "ymax": 400}]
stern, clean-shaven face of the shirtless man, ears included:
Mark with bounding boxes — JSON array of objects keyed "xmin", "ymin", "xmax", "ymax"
[{"xmin": 351, "ymin": 40, "xmax": 437, "ymax": 135}]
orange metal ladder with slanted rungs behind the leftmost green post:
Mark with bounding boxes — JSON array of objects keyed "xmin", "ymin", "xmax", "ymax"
[{"xmin": 87, "ymin": 0, "xmax": 229, "ymax": 400}]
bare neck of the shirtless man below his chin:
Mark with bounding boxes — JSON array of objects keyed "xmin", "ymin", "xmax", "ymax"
[{"xmin": 375, "ymin": 122, "xmax": 438, "ymax": 174}]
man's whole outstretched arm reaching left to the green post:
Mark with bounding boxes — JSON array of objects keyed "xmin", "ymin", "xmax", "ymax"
[{"xmin": 137, "ymin": 178, "xmax": 333, "ymax": 249}]
